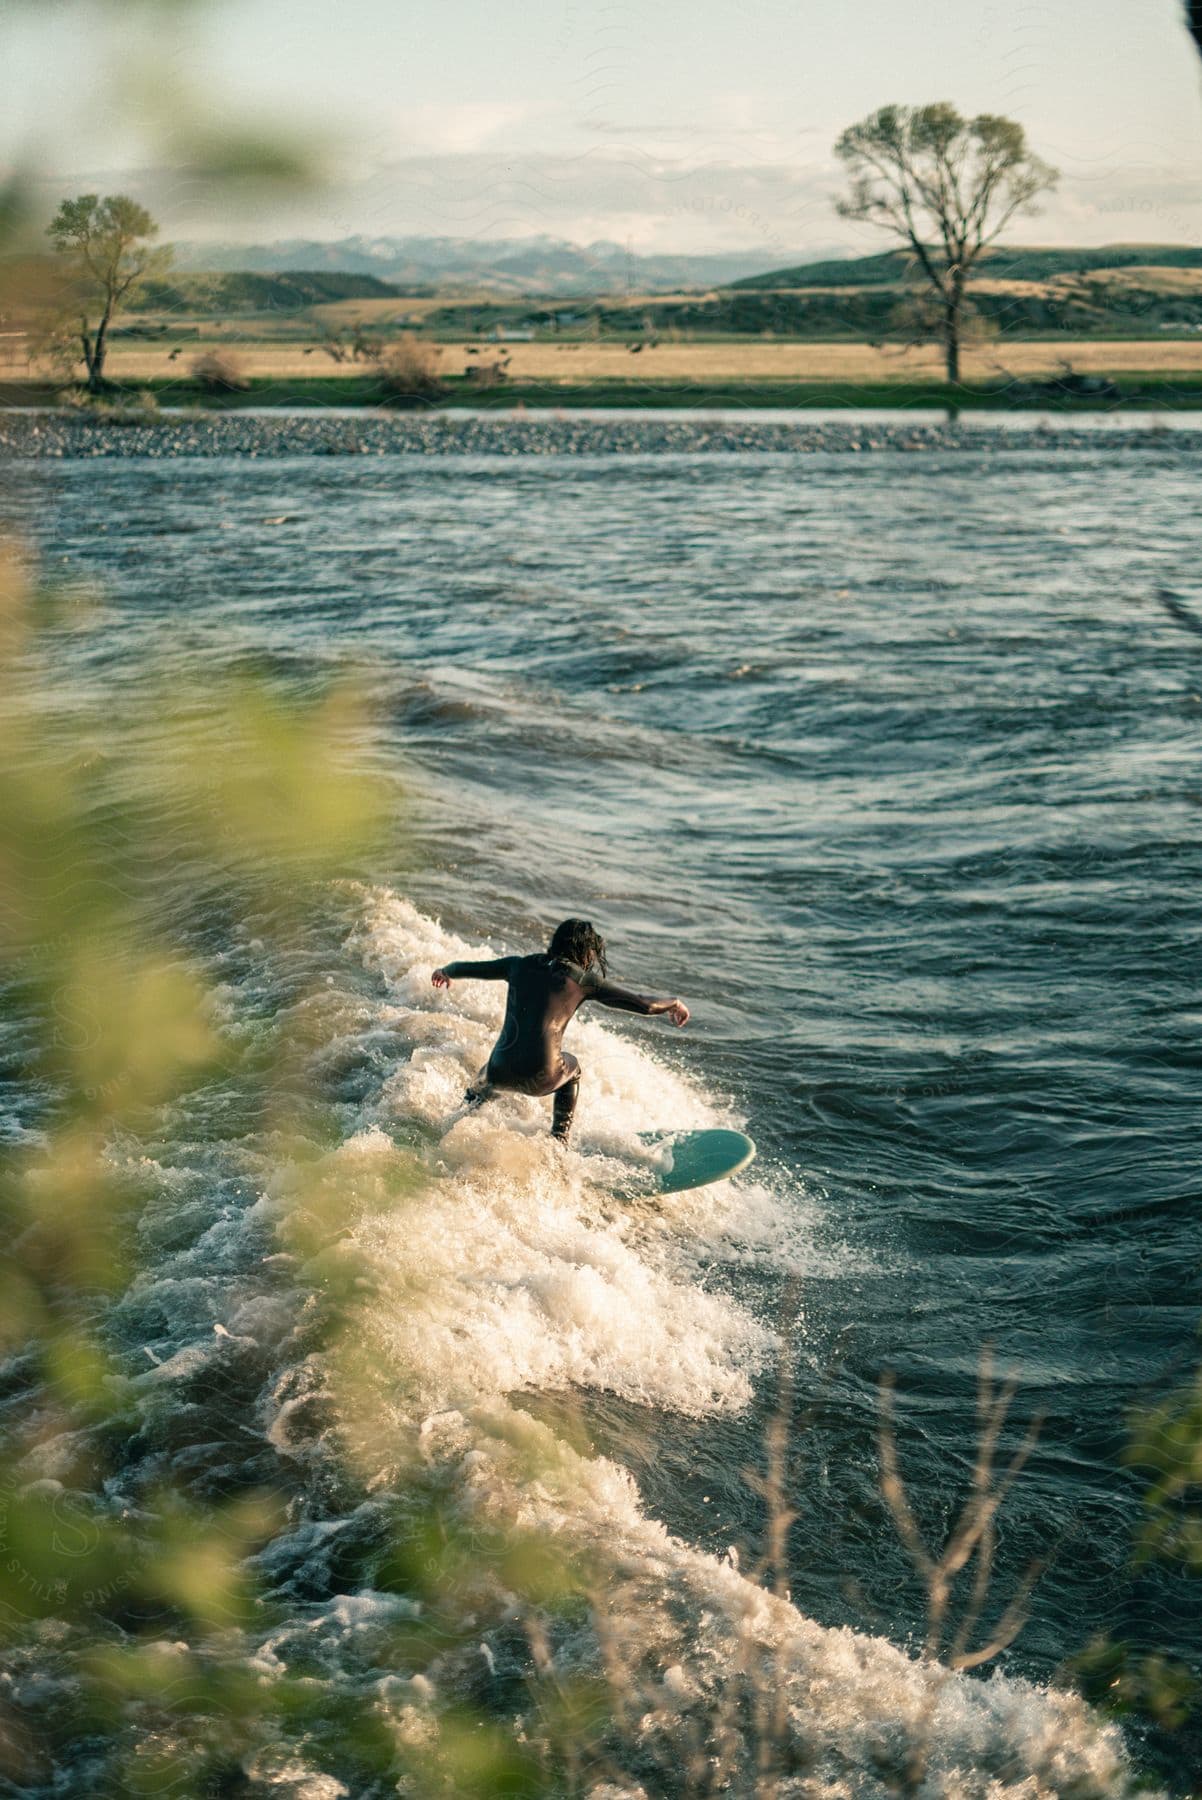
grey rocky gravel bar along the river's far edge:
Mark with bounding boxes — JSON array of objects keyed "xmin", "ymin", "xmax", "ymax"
[{"xmin": 0, "ymin": 410, "xmax": 1202, "ymax": 459}]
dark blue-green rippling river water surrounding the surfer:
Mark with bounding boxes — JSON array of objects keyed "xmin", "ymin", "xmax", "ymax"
[{"xmin": 2, "ymin": 428, "xmax": 1202, "ymax": 1793}]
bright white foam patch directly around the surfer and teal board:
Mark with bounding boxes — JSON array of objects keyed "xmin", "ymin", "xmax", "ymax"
[{"xmin": 332, "ymin": 891, "xmax": 802, "ymax": 1415}]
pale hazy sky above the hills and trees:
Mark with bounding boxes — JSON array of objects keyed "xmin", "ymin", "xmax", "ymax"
[{"xmin": 0, "ymin": 0, "xmax": 1202, "ymax": 261}]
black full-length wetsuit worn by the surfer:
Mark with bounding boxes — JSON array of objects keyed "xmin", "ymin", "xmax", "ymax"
[{"xmin": 444, "ymin": 952, "xmax": 669, "ymax": 1138}]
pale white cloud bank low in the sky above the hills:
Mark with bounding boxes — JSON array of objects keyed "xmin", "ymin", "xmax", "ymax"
[{"xmin": 25, "ymin": 144, "xmax": 1202, "ymax": 266}]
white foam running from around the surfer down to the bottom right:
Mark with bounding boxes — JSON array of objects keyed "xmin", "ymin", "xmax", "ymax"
[{"xmin": 323, "ymin": 891, "xmax": 1151, "ymax": 1800}]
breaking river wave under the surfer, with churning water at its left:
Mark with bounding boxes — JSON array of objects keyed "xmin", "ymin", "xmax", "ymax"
[{"xmin": 79, "ymin": 889, "xmax": 1130, "ymax": 1800}]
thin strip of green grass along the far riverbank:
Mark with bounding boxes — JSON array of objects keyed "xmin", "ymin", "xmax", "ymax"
[{"xmin": 0, "ymin": 374, "xmax": 1202, "ymax": 412}]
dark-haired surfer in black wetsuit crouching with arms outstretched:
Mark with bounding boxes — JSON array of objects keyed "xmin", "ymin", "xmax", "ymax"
[{"xmin": 430, "ymin": 918, "xmax": 689, "ymax": 1143}]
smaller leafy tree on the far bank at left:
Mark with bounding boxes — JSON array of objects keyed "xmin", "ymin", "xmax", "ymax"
[{"xmin": 47, "ymin": 194, "xmax": 171, "ymax": 391}]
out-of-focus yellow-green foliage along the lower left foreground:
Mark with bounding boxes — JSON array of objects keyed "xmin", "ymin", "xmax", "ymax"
[{"xmin": 0, "ymin": 544, "xmax": 608, "ymax": 1795}]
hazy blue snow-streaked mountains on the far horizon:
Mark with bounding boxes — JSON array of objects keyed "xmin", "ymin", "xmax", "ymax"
[{"xmin": 176, "ymin": 236, "xmax": 806, "ymax": 299}]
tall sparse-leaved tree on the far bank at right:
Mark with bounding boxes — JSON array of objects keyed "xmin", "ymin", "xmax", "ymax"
[{"xmin": 835, "ymin": 101, "xmax": 1058, "ymax": 382}]
